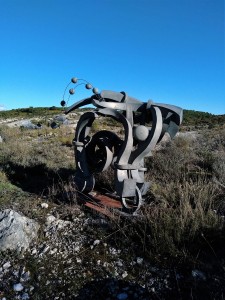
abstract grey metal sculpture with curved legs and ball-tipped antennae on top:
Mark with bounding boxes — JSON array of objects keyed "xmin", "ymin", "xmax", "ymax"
[{"xmin": 61, "ymin": 78, "xmax": 183, "ymax": 213}]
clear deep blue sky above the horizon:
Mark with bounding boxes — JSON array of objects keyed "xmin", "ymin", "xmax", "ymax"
[{"xmin": 0, "ymin": 0, "xmax": 225, "ymax": 114}]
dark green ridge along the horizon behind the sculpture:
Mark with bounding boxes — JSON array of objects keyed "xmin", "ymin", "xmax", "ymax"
[{"xmin": 0, "ymin": 106, "xmax": 225, "ymax": 128}]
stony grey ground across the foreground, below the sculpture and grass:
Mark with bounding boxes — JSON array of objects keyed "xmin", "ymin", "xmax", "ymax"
[{"xmin": 0, "ymin": 199, "xmax": 225, "ymax": 300}]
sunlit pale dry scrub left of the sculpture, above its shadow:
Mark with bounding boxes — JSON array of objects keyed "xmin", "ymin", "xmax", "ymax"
[{"xmin": 0, "ymin": 127, "xmax": 74, "ymax": 170}]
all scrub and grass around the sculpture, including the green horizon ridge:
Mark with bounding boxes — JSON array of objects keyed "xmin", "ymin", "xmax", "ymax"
[{"xmin": 0, "ymin": 108, "xmax": 225, "ymax": 299}]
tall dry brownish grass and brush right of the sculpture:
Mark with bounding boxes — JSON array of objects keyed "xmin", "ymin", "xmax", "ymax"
[{"xmin": 102, "ymin": 131, "xmax": 225, "ymax": 264}]
